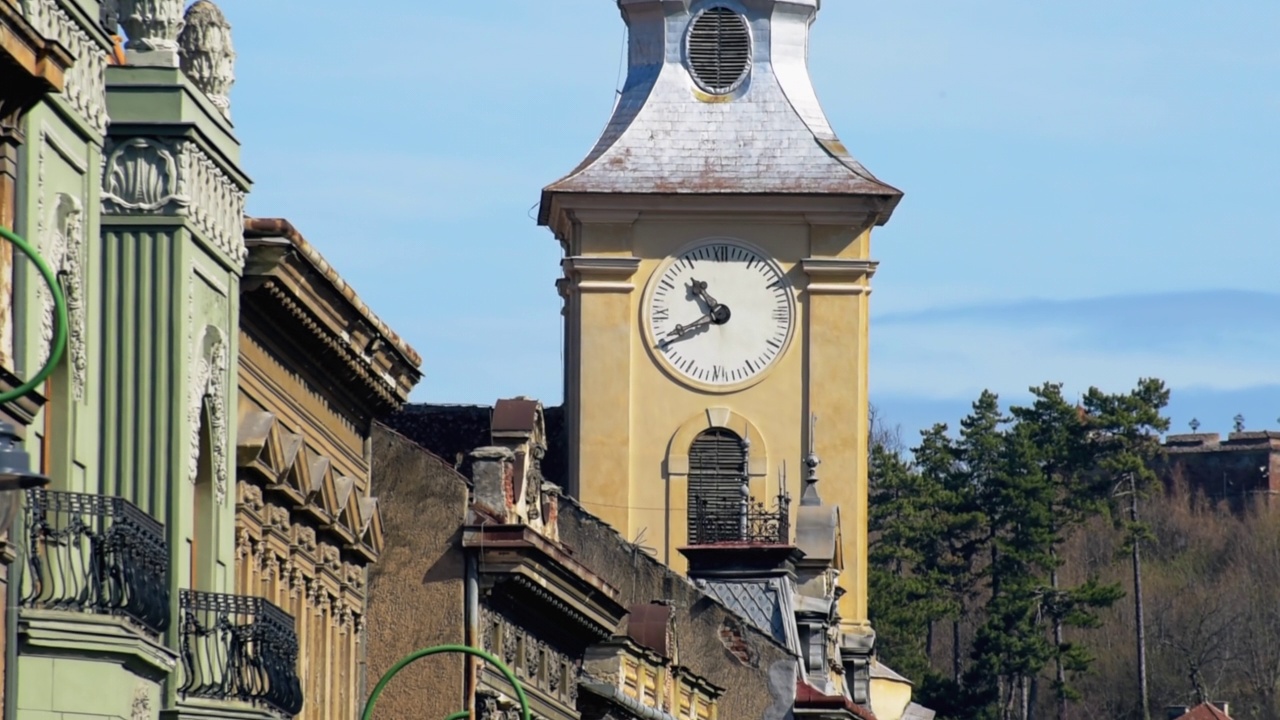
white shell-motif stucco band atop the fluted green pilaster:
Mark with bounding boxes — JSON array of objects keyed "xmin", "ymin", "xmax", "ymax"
[{"xmin": 102, "ymin": 137, "xmax": 246, "ymax": 264}]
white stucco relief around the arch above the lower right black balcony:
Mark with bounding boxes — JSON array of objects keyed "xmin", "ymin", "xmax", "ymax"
[{"xmin": 187, "ymin": 325, "xmax": 228, "ymax": 505}]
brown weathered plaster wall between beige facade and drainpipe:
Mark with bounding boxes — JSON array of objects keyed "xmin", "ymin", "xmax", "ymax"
[{"xmin": 366, "ymin": 424, "xmax": 467, "ymax": 717}]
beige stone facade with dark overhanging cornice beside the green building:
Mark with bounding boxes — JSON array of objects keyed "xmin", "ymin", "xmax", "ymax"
[{"xmin": 236, "ymin": 220, "xmax": 420, "ymax": 720}]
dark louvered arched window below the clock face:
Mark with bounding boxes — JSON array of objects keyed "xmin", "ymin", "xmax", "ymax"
[{"xmin": 689, "ymin": 428, "xmax": 746, "ymax": 544}]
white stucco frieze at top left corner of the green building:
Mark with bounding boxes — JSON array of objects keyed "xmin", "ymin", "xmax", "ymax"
[{"xmin": 26, "ymin": 0, "xmax": 108, "ymax": 135}]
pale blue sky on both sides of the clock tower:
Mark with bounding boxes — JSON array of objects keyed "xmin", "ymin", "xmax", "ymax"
[{"xmin": 220, "ymin": 0, "xmax": 1280, "ymax": 438}]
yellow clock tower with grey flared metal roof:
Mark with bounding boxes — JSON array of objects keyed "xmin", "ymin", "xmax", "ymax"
[{"xmin": 539, "ymin": 0, "xmax": 901, "ymax": 633}]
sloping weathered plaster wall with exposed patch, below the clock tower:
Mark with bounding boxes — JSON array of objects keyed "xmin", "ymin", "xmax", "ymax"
[{"xmin": 559, "ymin": 501, "xmax": 795, "ymax": 719}]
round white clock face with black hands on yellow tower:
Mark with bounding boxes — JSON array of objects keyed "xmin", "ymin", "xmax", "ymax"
[{"xmin": 644, "ymin": 240, "xmax": 795, "ymax": 389}]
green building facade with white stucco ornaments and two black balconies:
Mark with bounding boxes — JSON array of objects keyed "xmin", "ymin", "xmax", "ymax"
[{"xmin": 8, "ymin": 0, "xmax": 301, "ymax": 720}]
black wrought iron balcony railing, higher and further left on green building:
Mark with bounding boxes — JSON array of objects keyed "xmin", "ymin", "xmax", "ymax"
[{"xmin": 22, "ymin": 488, "xmax": 170, "ymax": 635}]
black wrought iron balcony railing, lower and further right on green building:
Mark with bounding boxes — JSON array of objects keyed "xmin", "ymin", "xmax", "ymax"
[{"xmin": 178, "ymin": 589, "xmax": 302, "ymax": 716}]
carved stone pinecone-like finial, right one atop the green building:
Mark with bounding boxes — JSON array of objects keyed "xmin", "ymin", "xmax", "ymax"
[{"xmin": 178, "ymin": 0, "xmax": 236, "ymax": 119}]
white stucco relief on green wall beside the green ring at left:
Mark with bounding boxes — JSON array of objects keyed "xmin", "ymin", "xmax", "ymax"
[{"xmin": 32, "ymin": 131, "xmax": 88, "ymax": 401}]
